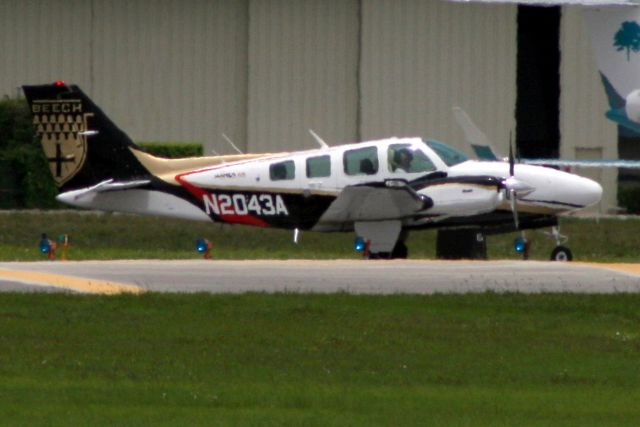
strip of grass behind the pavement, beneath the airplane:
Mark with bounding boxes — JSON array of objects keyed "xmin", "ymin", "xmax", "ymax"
[{"xmin": 0, "ymin": 211, "xmax": 640, "ymax": 262}]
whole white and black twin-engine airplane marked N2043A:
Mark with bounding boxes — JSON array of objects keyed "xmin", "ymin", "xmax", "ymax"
[{"xmin": 24, "ymin": 82, "xmax": 602, "ymax": 258}]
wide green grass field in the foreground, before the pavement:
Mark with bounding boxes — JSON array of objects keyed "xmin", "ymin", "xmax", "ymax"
[{"xmin": 0, "ymin": 293, "xmax": 640, "ymax": 426}]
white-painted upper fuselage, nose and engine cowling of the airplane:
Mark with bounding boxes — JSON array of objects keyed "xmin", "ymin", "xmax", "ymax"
[{"xmin": 184, "ymin": 138, "xmax": 602, "ymax": 222}]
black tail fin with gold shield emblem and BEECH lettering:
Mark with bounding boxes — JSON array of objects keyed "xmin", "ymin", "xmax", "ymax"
[{"xmin": 23, "ymin": 82, "xmax": 151, "ymax": 191}]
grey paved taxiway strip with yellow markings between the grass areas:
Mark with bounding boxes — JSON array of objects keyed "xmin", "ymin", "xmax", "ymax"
[{"xmin": 0, "ymin": 260, "xmax": 640, "ymax": 294}]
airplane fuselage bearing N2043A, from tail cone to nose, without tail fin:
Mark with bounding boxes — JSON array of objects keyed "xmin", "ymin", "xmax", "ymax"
[{"xmin": 59, "ymin": 138, "xmax": 602, "ymax": 230}]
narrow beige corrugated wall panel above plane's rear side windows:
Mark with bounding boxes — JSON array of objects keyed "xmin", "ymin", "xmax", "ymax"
[{"xmin": 248, "ymin": 0, "xmax": 359, "ymax": 152}]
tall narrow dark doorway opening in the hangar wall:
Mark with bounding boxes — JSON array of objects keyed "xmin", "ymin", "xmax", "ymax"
[{"xmin": 516, "ymin": 6, "xmax": 560, "ymax": 158}]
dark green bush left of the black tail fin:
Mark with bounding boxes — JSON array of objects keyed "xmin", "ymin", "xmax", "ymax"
[{"xmin": 0, "ymin": 98, "xmax": 59, "ymax": 209}]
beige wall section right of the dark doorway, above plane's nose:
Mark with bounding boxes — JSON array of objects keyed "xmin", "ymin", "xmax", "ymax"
[{"xmin": 560, "ymin": 7, "xmax": 618, "ymax": 213}]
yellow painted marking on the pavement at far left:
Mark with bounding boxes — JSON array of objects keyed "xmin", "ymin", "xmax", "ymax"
[{"xmin": 0, "ymin": 268, "xmax": 144, "ymax": 295}]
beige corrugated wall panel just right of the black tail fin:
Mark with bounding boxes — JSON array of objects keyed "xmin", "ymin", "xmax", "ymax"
[{"xmin": 93, "ymin": 0, "xmax": 247, "ymax": 147}]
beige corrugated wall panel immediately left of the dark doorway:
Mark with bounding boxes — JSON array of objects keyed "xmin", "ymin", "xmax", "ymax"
[{"xmin": 361, "ymin": 0, "xmax": 517, "ymax": 157}]
